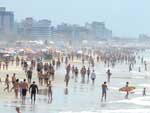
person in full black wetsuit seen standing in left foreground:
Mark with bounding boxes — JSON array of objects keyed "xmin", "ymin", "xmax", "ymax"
[{"xmin": 29, "ymin": 81, "xmax": 38, "ymax": 104}]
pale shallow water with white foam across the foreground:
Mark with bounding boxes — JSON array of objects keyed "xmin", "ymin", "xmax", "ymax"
[{"xmin": 0, "ymin": 50, "xmax": 150, "ymax": 113}]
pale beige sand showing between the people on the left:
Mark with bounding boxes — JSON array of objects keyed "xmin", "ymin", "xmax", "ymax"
[{"xmin": 0, "ymin": 64, "xmax": 64, "ymax": 101}]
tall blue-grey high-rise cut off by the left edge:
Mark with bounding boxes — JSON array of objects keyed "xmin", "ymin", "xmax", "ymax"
[{"xmin": 0, "ymin": 7, "xmax": 14, "ymax": 34}]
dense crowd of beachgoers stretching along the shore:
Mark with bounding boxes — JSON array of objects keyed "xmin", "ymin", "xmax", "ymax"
[{"xmin": 0, "ymin": 48, "xmax": 147, "ymax": 113}]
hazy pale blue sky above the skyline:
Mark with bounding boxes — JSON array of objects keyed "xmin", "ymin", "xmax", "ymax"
[{"xmin": 0, "ymin": 0, "xmax": 150, "ymax": 37}]
